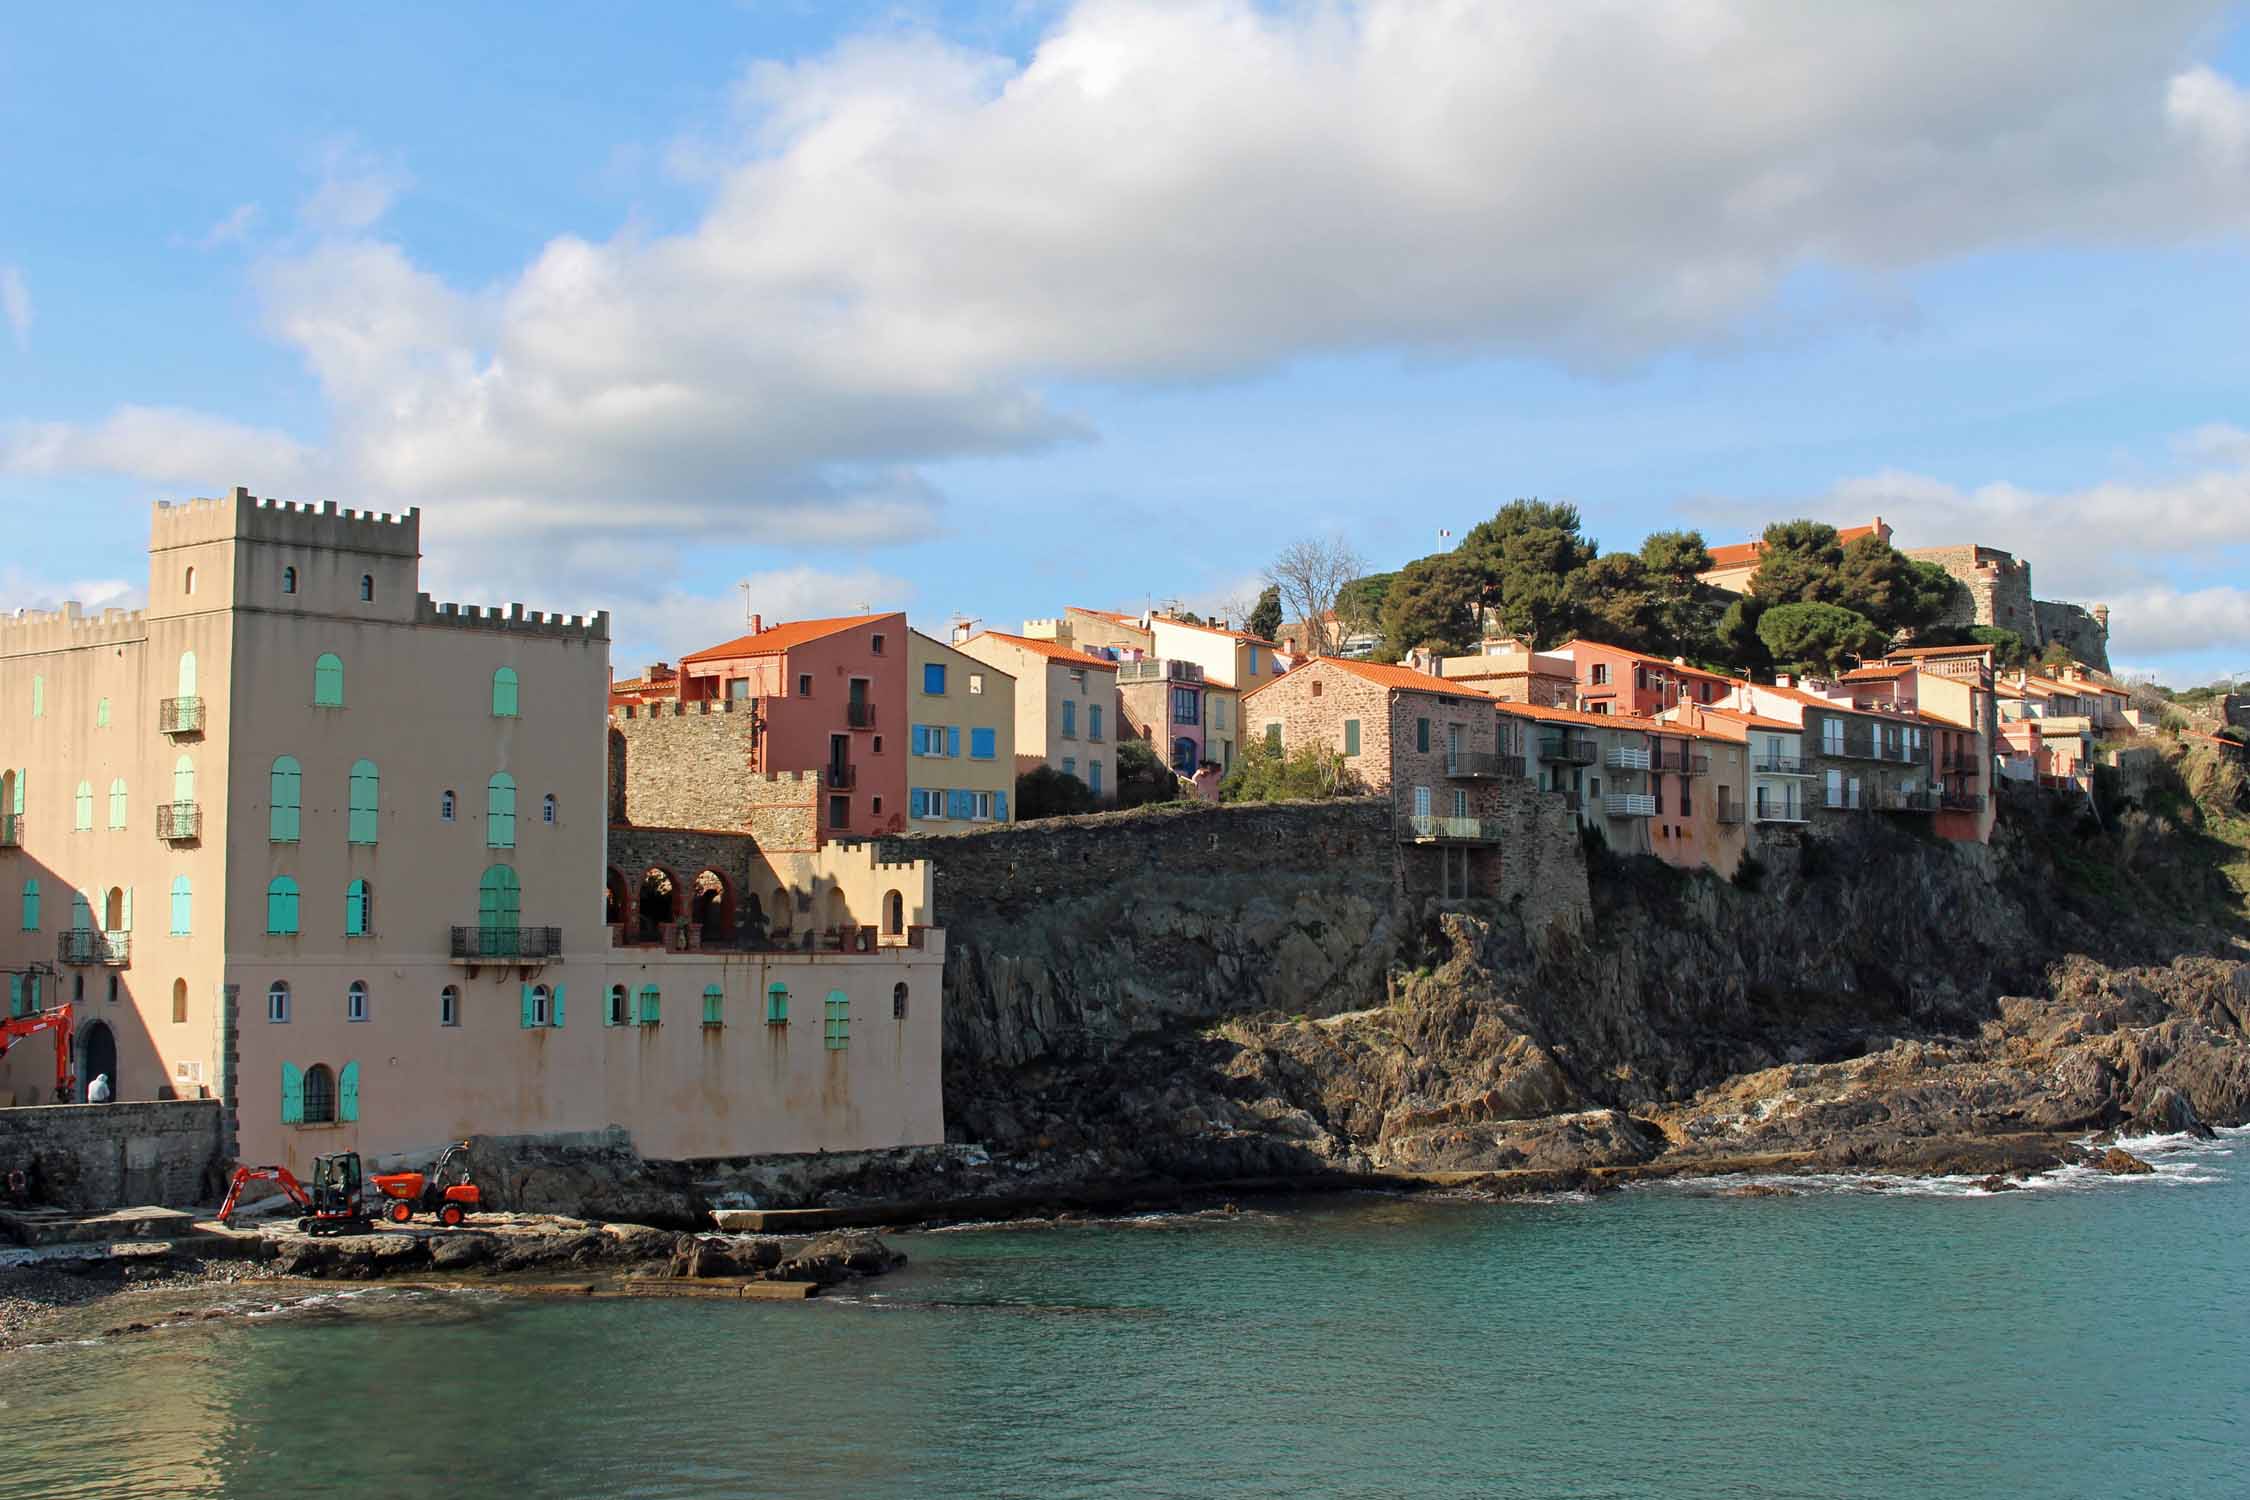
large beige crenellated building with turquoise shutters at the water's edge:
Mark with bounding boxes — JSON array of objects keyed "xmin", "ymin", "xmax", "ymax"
[{"xmin": 0, "ymin": 490, "xmax": 945, "ymax": 1172}]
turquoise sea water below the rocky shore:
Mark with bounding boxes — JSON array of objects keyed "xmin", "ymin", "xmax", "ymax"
[{"xmin": 0, "ymin": 1133, "xmax": 2250, "ymax": 1500}]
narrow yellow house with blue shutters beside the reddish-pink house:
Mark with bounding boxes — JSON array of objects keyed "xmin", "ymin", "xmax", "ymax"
[{"xmin": 907, "ymin": 630, "xmax": 1015, "ymax": 832}]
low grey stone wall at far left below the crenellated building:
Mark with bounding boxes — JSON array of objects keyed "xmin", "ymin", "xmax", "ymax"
[{"xmin": 0, "ymin": 1100, "xmax": 225, "ymax": 1214}]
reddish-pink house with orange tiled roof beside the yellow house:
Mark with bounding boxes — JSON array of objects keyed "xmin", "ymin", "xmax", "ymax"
[{"xmin": 680, "ymin": 614, "xmax": 911, "ymax": 843}]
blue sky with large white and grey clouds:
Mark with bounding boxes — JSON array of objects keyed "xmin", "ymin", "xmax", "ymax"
[{"xmin": 0, "ymin": 0, "xmax": 2250, "ymax": 686}]
